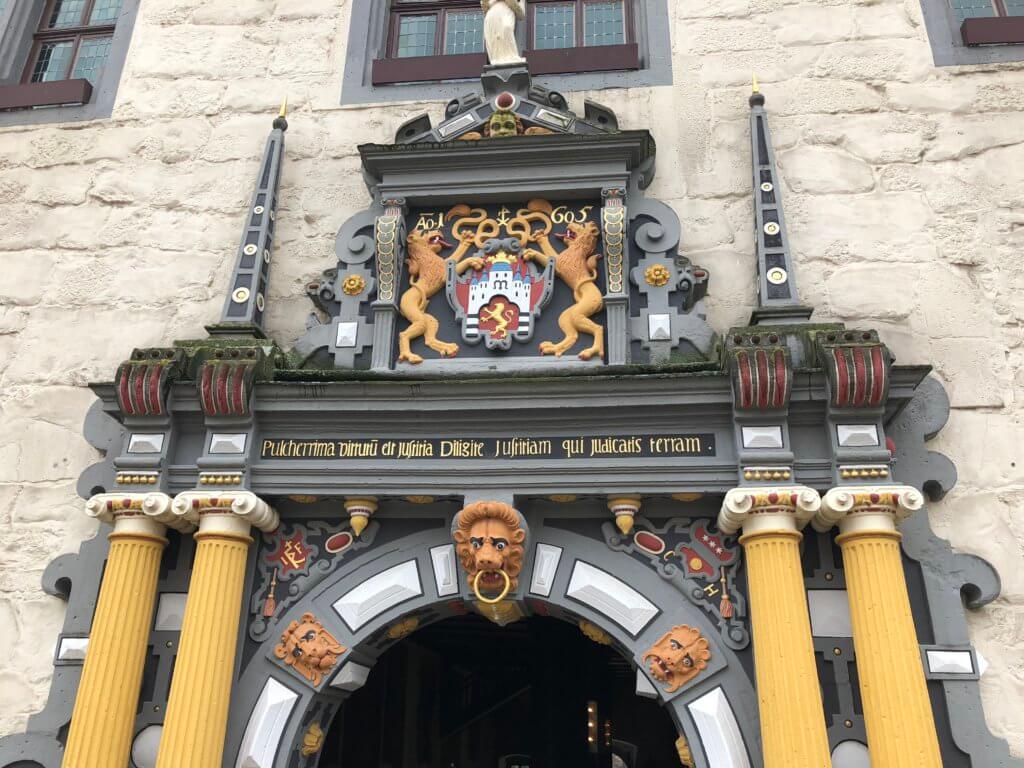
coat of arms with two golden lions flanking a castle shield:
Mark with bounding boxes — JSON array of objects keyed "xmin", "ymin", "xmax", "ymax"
[{"xmin": 398, "ymin": 200, "xmax": 604, "ymax": 365}]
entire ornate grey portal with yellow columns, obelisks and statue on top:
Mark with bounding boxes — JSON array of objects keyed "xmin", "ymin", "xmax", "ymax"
[{"xmin": 0, "ymin": 60, "xmax": 1015, "ymax": 768}]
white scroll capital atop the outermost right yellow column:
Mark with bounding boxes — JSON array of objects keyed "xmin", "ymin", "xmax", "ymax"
[{"xmin": 812, "ymin": 485, "xmax": 925, "ymax": 532}]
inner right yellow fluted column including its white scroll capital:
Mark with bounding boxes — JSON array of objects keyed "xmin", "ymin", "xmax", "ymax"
[{"xmin": 719, "ymin": 486, "xmax": 831, "ymax": 768}]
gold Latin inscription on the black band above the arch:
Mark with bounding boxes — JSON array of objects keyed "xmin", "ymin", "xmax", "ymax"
[{"xmin": 260, "ymin": 434, "xmax": 715, "ymax": 461}]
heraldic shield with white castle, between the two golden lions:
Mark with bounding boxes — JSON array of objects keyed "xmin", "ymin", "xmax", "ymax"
[{"xmin": 447, "ymin": 231, "xmax": 555, "ymax": 350}]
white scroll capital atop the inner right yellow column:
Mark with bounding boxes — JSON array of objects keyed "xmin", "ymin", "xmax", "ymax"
[{"xmin": 718, "ymin": 485, "xmax": 821, "ymax": 535}]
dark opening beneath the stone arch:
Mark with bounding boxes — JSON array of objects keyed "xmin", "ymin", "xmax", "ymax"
[{"xmin": 319, "ymin": 614, "xmax": 679, "ymax": 768}]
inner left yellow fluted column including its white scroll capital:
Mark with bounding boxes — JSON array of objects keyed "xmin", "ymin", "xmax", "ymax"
[{"xmin": 157, "ymin": 492, "xmax": 278, "ymax": 768}]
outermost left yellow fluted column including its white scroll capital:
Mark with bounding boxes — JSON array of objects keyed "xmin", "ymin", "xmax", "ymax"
[{"xmin": 62, "ymin": 494, "xmax": 188, "ymax": 768}]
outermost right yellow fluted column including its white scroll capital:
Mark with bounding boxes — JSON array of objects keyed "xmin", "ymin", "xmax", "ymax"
[{"xmin": 814, "ymin": 485, "xmax": 942, "ymax": 768}]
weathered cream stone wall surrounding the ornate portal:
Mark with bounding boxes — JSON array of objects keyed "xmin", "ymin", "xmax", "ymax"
[{"xmin": 0, "ymin": 0, "xmax": 1024, "ymax": 755}]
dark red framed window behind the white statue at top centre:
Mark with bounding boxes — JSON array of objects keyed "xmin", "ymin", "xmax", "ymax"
[{"xmin": 373, "ymin": 0, "xmax": 640, "ymax": 85}]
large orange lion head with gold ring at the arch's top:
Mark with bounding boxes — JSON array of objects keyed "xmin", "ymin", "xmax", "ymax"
[{"xmin": 453, "ymin": 502, "xmax": 526, "ymax": 592}]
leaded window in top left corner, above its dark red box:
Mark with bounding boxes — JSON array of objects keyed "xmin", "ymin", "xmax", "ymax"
[{"xmin": 22, "ymin": 0, "xmax": 123, "ymax": 85}]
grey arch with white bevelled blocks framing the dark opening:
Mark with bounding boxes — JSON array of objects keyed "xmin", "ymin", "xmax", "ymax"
[{"xmin": 225, "ymin": 508, "xmax": 761, "ymax": 768}]
